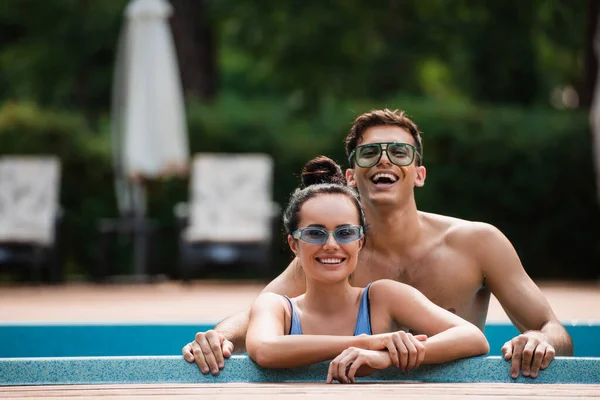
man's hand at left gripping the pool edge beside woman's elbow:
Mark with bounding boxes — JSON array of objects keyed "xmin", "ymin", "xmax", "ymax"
[{"xmin": 181, "ymin": 329, "xmax": 233, "ymax": 375}]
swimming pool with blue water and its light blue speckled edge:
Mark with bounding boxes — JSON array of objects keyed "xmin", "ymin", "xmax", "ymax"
[{"xmin": 0, "ymin": 322, "xmax": 600, "ymax": 386}]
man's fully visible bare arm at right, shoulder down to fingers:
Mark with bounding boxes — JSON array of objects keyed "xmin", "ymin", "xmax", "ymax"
[{"xmin": 469, "ymin": 223, "xmax": 573, "ymax": 378}]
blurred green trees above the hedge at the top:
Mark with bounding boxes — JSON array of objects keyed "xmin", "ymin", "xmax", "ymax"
[{"xmin": 0, "ymin": 0, "xmax": 587, "ymax": 109}]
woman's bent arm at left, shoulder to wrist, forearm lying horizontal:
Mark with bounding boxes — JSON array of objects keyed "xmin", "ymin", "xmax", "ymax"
[{"xmin": 246, "ymin": 293, "xmax": 376, "ymax": 368}]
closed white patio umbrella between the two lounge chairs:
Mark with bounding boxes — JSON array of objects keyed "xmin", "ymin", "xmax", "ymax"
[{"xmin": 111, "ymin": 0, "xmax": 189, "ymax": 273}]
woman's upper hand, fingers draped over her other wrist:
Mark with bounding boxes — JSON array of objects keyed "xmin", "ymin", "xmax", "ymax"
[{"xmin": 368, "ymin": 331, "xmax": 427, "ymax": 372}]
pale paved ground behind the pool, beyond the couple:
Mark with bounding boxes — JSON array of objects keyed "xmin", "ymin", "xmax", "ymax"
[{"xmin": 0, "ymin": 281, "xmax": 600, "ymax": 322}]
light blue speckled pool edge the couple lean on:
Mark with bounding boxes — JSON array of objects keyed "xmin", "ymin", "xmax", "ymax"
[{"xmin": 0, "ymin": 355, "xmax": 600, "ymax": 386}]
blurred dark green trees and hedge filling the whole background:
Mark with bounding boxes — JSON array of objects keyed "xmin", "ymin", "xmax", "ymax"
[{"xmin": 0, "ymin": 0, "xmax": 600, "ymax": 282}]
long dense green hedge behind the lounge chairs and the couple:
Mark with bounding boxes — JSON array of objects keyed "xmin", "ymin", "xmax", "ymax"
[{"xmin": 0, "ymin": 94, "xmax": 600, "ymax": 279}]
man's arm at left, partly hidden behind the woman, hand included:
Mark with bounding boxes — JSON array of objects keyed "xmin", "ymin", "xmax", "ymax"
[{"xmin": 181, "ymin": 259, "xmax": 306, "ymax": 375}]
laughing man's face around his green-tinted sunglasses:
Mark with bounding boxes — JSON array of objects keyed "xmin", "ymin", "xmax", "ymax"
[{"xmin": 346, "ymin": 125, "xmax": 425, "ymax": 205}]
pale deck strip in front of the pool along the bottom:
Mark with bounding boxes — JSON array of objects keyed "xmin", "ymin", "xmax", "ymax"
[{"xmin": 0, "ymin": 383, "xmax": 600, "ymax": 400}]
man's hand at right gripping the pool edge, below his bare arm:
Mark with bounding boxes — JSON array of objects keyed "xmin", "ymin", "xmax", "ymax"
[{"xmin": 502, "ymin": 331, "xmax": 556, "ymax": 379}]
